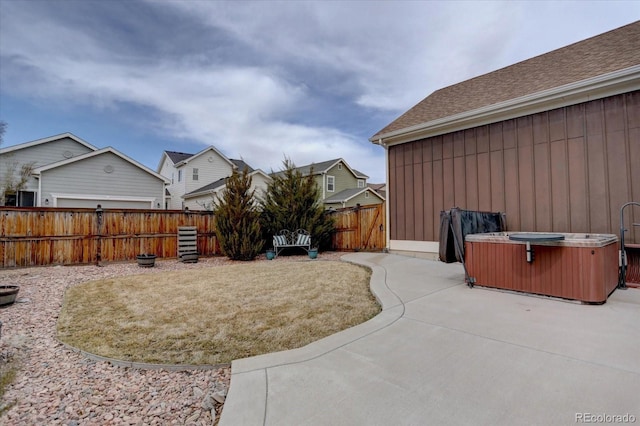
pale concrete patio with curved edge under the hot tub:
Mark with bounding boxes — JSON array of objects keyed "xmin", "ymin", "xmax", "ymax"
[{"xmin": 220, "ymin": 253, "xmax": 640, "ymax": 426}]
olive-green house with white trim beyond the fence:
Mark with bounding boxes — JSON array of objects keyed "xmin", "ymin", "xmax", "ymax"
[{"xmin": 275, "ymin": 158, "xmax": 384, "ymax": 208}]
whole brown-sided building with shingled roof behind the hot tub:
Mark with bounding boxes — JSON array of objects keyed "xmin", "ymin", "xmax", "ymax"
[{"xmin": 370, "ymin": 21, "xmax": 640, "ymax": 254}]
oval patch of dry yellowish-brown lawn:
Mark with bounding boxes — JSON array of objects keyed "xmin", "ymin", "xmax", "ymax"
[{"xmin": 57, "ymin": 261, "xmax": 380, "ymax": 365}]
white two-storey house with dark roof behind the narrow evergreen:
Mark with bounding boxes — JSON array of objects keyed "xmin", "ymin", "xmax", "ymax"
[{"xmin": 158, "ymin": 146, "xmax": 271, "ymax": 210}]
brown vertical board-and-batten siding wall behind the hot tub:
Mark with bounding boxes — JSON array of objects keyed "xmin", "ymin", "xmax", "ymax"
[{"xmin": 387, "ymin": 90, "xmax": 640, "ymax": 244}]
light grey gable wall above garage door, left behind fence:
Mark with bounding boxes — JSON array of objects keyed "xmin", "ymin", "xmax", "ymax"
[{"xmin": 40, "ymin": 152, "xmax": 164, "ymax": 208}]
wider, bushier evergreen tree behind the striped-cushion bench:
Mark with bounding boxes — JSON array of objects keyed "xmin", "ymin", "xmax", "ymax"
[{"xmin": 261, "ymin": 159, "xmax": 334, "ymax": 249}]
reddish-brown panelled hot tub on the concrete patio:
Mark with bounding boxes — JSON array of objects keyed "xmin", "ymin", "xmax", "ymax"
[{"xmin": 465, "ymin": 232, "xmax": 618, "ymax": 303}]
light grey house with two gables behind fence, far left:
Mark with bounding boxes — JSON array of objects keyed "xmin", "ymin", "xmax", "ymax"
[{"xmin": 0, "ymin": 133, "xmax": 168, "ymax": 209}]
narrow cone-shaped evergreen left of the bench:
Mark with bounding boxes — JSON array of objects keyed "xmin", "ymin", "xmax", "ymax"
[{"xmin": 214, "ymin": 169, "xmax": 264, "ymax": 260}]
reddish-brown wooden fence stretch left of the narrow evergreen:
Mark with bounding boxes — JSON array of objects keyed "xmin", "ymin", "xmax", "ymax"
[{"xmin": 0, "ymin": 207, "xmax": 220, "ymax": 268}]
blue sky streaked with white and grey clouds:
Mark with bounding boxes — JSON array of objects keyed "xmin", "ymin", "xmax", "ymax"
[{"xmin": 0, "ymin": 0, "xmax": 640, "ymax": 182}]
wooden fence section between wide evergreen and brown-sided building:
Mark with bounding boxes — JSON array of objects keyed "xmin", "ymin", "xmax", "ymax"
[{"xmin": 331, "ymin": 204, "xmax": 386, "ymax": 251}]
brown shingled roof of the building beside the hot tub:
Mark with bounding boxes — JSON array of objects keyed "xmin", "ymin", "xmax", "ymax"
[{"xmin": 370, "ymin": 21, "xmax": 640, "ymax": 142}]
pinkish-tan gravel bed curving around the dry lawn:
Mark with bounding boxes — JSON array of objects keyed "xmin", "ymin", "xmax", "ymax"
[{"xmin": 0, "ymin": 253, "xmax": 343, "ymax": 426}]
